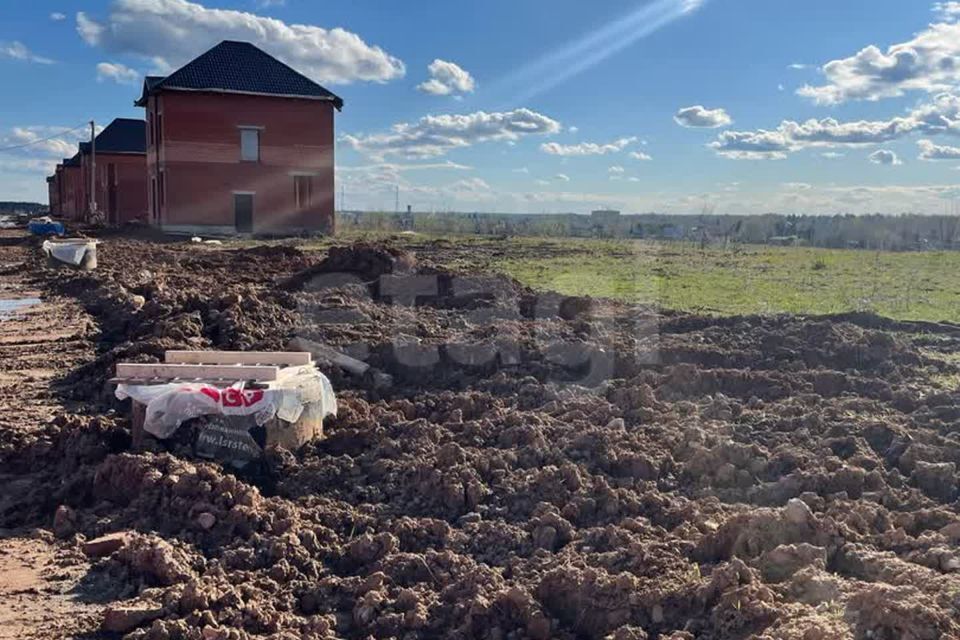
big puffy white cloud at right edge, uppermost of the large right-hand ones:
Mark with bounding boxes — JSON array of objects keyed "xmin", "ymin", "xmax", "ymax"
[{"xmin": 797, "ymin": 17, "xmax": 960, "ymax": 104}]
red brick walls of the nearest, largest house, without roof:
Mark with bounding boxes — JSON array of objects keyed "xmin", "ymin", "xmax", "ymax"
[{"xmin": 146, "ymin": 91, "xmax": 334, "ymax": 233}]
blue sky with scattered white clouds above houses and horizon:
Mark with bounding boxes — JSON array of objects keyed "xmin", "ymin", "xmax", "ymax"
[{"xmin": 0, "ymin": 0, "xmax": 960, "ymax": 214}]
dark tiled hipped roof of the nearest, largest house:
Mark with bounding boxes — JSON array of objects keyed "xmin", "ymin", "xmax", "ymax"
[{"xmin": 136, "ymin": 40, "xmax": 343, "ymax": 109}]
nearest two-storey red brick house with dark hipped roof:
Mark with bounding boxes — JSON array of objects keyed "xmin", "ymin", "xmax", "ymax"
[{"xmin": 136, "ymin": 41, "xmax": 343, "ymax": 235}]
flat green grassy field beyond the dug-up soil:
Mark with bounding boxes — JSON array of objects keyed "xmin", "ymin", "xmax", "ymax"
[{"xmin": 274, "ymin": 231, "xmax": 960, "ymax": 322}]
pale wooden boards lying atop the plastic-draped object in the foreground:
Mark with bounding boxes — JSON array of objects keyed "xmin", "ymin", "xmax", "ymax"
[{"xmin": 110, "ymin": 351, "xmax": 312, "ymax": 386}]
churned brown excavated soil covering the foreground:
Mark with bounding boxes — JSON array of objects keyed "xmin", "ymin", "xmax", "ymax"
[{"xmin": 0, "ymin": 232, "xmax": 960, "ymax": 640}]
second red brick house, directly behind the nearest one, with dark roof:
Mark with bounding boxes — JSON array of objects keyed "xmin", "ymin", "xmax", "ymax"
[{"xmin": 80, "ymin": 118, "xmax": 147, "ymax": 224}]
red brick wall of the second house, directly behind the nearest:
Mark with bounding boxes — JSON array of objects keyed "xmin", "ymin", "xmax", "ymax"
[{"xmin": 81, "ymin": 153, "xmax": 147, "ymax": 224}]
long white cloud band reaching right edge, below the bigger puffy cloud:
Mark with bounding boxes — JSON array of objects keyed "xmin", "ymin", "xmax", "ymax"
[{"xmin": 708, "ymin": 94, "xmax": 960, "ymax": 160}]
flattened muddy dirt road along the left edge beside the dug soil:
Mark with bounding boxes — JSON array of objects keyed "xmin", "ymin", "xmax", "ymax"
[{"xmin": 0, "ymin": 230, "xmax": 100, "ymax": 640}]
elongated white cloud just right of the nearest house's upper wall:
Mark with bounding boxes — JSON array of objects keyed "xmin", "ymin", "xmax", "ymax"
[{"xmin": 341, "ymin": 109, "xmax": 560, "ymax": 158}]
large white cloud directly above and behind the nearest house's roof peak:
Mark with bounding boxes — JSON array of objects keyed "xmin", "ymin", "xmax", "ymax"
[{"xmin": 77, "ymin": 0, "xmax": 405, "ymax": 83}]
